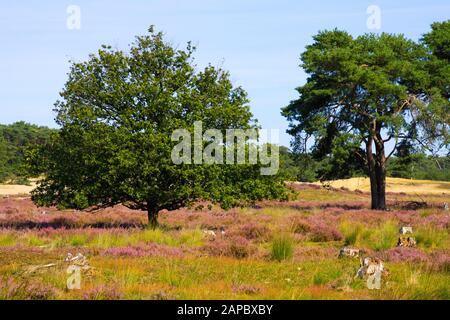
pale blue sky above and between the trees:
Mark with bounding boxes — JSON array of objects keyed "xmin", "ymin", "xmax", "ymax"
[{"xmin": 0, "ymin": 0, "xmax": 450, "ymax": 145}]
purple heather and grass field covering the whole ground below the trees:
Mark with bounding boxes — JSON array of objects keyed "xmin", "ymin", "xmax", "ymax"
[{"xmin": 0, "ymin": 184, "xmax": 450, "ymax": 299}]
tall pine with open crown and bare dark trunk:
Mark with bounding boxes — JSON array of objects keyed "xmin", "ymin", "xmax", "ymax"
[{"xmin": 283, "ymin": 21, "xmax": 450, "ymax": 210}]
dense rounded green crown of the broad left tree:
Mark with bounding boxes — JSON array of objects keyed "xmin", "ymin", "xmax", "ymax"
[{"xmin": 28, "ymin": 28, "xmax": 285, "ymax": 223}]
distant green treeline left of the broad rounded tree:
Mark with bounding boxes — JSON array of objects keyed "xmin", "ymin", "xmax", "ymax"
[{"xmin": 0, "ymin": 122, "xmax": 56, "ymax": 184}]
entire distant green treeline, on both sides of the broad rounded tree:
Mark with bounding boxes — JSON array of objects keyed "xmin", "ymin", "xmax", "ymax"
[{"xmin": 0, "ymin": 122, "xmax": 450, "ymax": 184}]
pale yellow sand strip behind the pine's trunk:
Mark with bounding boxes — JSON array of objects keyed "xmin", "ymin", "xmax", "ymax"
[{"xmin": 315, "ymin": 178, "xmax": 450, "ymax": 194}]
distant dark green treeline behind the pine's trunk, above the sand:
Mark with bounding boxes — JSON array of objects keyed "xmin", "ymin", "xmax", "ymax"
[{"xmin": 280, "ymin": 147, "xmax": 450, "ymax": 182}]
